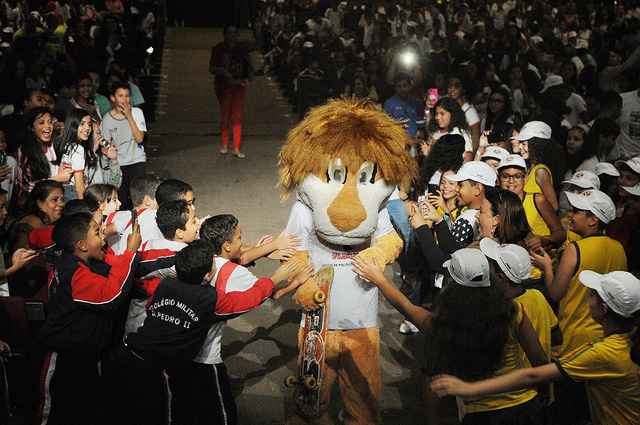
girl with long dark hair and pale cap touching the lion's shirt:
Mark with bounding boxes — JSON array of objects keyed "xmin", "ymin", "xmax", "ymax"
[{"xmin": 353, "ymin": 248, "xmax": 546, "ymax": 423}]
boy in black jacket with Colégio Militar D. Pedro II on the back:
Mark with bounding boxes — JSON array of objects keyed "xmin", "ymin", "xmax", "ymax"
[{"xmin": 118, "ymin": 240, "xmax": 312, "ymax": 425}]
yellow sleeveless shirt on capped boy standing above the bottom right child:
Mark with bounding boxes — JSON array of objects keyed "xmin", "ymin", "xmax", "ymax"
[{"xmin": 553, "ymin": 236, "xmax": 627, "ymax": 357}]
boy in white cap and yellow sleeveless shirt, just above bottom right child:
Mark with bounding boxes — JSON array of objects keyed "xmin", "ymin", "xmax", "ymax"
[{"xmin": 539, "ymin": 189, "xmax": 627, "ymax": 356}]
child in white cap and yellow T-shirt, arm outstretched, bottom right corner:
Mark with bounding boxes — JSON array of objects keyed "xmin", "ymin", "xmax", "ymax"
[{"xmin": 431, "ymin": 270, "xmax": 640, "ymax": 425}]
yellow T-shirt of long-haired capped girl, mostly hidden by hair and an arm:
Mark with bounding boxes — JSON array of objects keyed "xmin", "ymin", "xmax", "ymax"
[{"xmin": 464, "ymin": 302, "xmax": 538, "ymax": 413}]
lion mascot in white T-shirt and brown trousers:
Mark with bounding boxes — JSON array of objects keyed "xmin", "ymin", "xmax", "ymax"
[{"xmin": 279, "ymin": 99, "xmax": 417, "ymax": 424}]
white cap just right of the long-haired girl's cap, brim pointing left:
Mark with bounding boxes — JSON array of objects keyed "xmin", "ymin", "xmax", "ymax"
[{"xmin": 480, "ymin": 238, "xmax": 531, "ymax": 283}]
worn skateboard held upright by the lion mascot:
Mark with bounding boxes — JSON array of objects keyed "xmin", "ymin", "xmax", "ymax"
[{"xmin": 285, "ymin": 266, "xmax": 333, "ymax": 418}]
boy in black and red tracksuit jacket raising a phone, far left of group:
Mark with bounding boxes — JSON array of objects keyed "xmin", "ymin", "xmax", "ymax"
[{"xmin": 38, "ymin": 213, "xmax": 145, "ymax": 425}]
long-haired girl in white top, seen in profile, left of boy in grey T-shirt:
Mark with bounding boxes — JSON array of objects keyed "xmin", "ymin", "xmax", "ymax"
[{"xmin": 58, "ymin": 109, "xmax": 96, "ymax": 201}]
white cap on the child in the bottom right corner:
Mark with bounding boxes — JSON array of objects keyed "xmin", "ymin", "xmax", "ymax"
[{"xmin": 578, "ymin": 270, "xmax": 640, "ymax": 317}]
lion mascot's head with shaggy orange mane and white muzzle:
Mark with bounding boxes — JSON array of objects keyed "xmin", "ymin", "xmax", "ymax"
[{"xmin": 279, "ymin": 98, "xmax": 417, "ymax": 245}]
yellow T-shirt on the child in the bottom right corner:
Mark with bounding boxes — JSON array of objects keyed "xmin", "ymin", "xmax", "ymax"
[{"xmin": 557, "ymin": 334, "xmax": 640, "ymax": 425}]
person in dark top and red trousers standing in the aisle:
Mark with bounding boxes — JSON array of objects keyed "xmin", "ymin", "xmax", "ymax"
[{"xmin": 209, "ymin": 26, "xmax": 251, "ymax": 158}]
